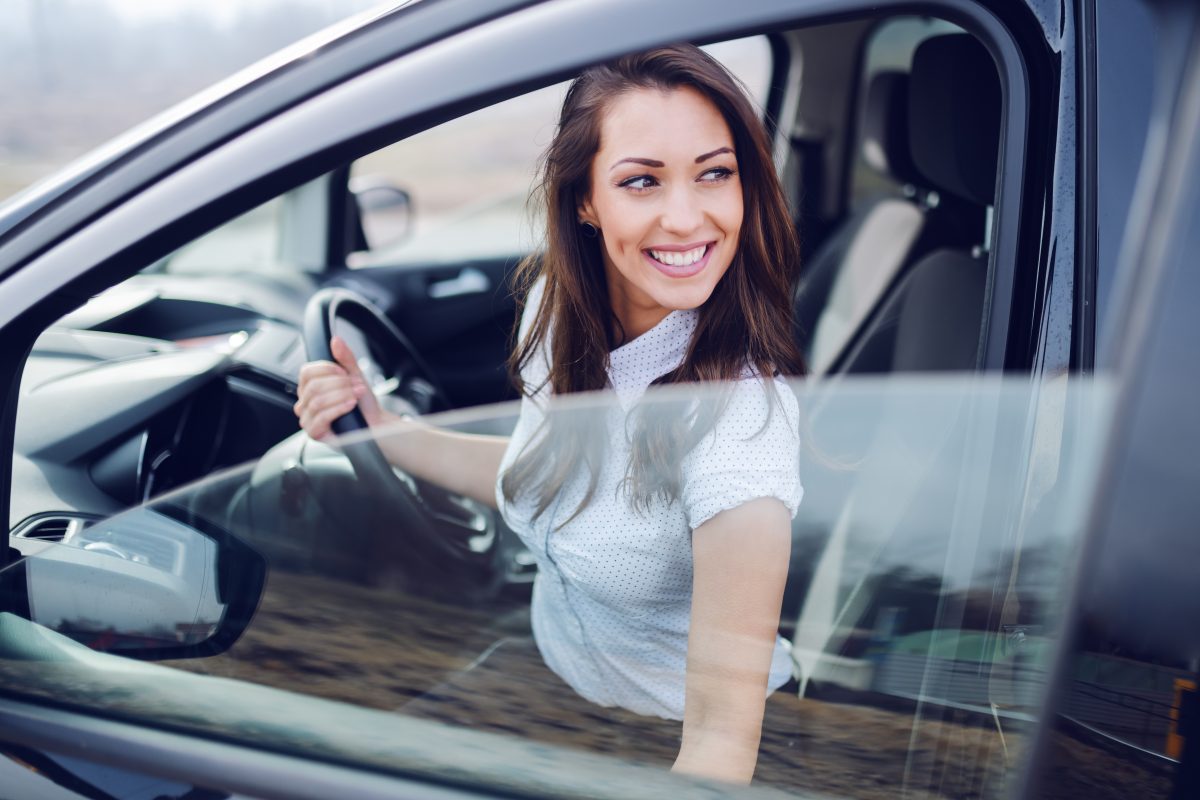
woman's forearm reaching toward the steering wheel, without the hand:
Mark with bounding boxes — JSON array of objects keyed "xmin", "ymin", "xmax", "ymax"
[{"xmin": 373, "ymin": 413, "xmax": 509, "ymax": 509}]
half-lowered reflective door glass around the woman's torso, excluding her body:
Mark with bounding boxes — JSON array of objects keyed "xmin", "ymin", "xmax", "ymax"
[{"xmin": 0, "ymin": 379, "xmax": 1108, "ymax": 798}]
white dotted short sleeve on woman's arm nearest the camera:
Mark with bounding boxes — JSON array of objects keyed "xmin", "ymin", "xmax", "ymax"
[{"xmin": 680, "ymin": 375, "xmax": 804, "ymax": 530}]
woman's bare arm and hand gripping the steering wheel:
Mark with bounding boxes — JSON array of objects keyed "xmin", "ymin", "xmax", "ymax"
[{"xmin": 293, "ymin": 337, "xmax": 509, "ymax": 509}]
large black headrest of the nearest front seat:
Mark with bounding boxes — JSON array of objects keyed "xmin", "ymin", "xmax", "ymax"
[{"xmin": 908, "ymin": 34, "xmax": 1001, "ymax": 205}]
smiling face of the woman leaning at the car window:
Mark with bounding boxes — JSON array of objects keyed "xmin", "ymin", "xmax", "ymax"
[{"xmin": 580, "ymin": 89, "xmax": 743, "ymax": 338}]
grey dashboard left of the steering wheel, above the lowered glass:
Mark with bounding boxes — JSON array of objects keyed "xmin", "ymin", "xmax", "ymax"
[{"xmin": 10, "ymin": 276, "xmax": 307, "ymax": 543}]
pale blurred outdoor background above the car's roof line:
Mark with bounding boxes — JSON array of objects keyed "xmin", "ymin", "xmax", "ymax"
[{"xmin": 0, "ymin": 0, "xmax": 381, "ymax": 200}]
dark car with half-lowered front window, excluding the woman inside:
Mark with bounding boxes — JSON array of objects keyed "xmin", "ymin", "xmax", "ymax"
[{"xmin": 0, "ymin": 0, "xmax": 1200, "ymax": 798}]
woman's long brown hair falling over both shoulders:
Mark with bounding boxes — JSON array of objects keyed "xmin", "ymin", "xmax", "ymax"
[{"xmin": 502, "ymin": 44, "xmax": 804, "ymax": 516}]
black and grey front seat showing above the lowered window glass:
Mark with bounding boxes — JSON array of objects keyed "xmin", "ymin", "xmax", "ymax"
[{"xmin": 796, "ymin": 34, "xmax": 1001, "ymax": 374}]
